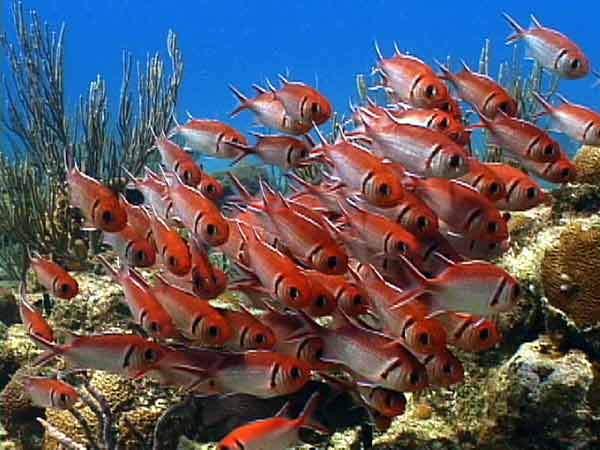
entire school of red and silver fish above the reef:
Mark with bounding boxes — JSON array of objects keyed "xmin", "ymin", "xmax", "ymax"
[{"xmin": 20, "ymin": 15, "xmax": 600, "ymax": 450}]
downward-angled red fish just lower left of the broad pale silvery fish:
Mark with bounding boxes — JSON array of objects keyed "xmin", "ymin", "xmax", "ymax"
[{"xmin": 352, "ymin": 264, "xmax": 446, "ymax": 354}]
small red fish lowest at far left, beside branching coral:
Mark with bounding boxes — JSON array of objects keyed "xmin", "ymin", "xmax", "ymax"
[{"xmin": 23, "ymin": 377, "xmax": 79, "ymax": 409}]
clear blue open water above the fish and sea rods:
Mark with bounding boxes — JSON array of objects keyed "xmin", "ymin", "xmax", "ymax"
[{"xmin": 2, "ymin": 0, "xmax": 600, "ymax": 170}]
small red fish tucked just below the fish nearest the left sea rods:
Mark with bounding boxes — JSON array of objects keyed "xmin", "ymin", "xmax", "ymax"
[{"xmin": 103, "ymin": 224, "xmax": 156, "ymax": 267}]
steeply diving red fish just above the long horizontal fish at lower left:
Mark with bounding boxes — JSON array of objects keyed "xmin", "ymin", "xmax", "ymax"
[{"xmin": 98, "ymin": 256, "xmax": 180, "ymax": 339}]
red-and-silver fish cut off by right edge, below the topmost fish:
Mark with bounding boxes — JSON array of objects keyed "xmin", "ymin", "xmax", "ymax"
[{"xmin": 531, "ymin": 92, "xmax": 600, "ymax": 147}]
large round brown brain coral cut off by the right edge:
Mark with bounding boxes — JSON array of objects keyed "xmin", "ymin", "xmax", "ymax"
[{"xmin": 542, "ymin": 223, "xmax": 600, "ymax": 328}]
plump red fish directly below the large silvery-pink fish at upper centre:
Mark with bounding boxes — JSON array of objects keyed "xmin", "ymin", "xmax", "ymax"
[{"xmin": 317, "ymin": 130, "xmax": 404, "ymax": 208}]
